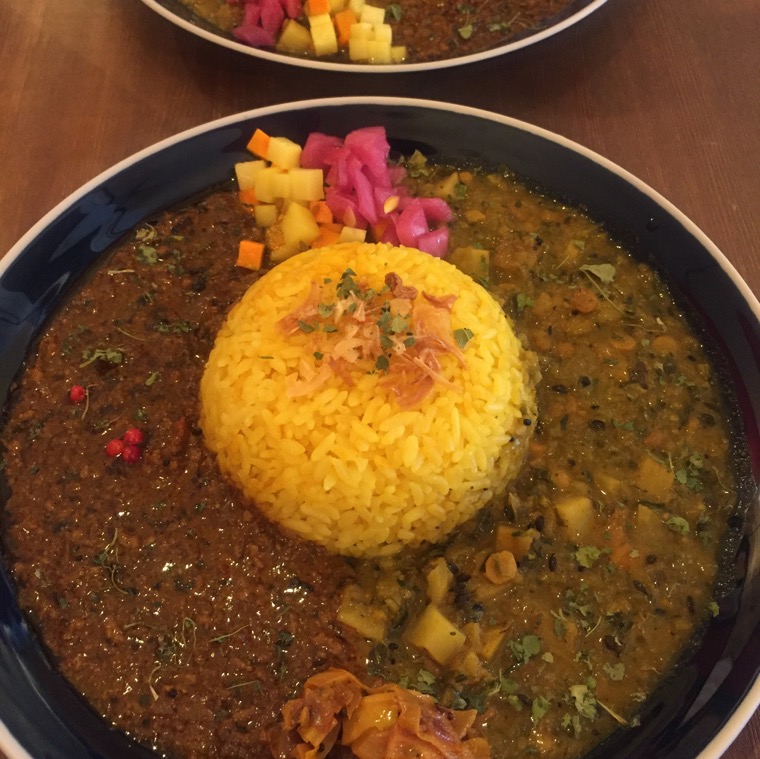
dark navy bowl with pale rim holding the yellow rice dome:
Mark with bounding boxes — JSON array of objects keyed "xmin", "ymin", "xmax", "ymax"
[{"xmin": 0, "ymin": 98, "xmax": 760, "ymax": 759}]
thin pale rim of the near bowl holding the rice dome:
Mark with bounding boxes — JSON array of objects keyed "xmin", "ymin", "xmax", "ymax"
[{"xmin": 0, "ymin": 96, "xmax": 760, "ymax": 759}]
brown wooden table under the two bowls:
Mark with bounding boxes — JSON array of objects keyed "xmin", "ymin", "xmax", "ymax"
[{"xmin": 0, "ymin": 0, "xmax": 760, "ymax": 759}]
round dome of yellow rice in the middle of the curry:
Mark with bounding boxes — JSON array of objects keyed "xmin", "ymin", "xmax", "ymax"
[{"xmin": 201, "ymin": 243, "xmax": 535, "ymax": 556}]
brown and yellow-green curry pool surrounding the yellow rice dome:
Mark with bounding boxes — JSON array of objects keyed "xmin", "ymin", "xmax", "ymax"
[{"xmin": 4, "ymin": 158, "xmax": 736, "ymax": 759}]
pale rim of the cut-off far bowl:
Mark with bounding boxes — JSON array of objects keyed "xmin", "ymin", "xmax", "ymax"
[{"xmin": 142, "ymin": 0, "xmax": 607, "ymax": 74}]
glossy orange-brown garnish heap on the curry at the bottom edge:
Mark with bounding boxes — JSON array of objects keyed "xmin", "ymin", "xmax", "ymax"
[{"xmin": 268, "ymin": 669, "xmax": 491, "ymax": 759}]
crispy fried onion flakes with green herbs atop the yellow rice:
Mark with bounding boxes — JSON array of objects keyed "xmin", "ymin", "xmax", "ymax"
[{"xmin": 279, "ymin": 269, "xmax": 472, "ymax": 408}]
